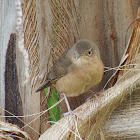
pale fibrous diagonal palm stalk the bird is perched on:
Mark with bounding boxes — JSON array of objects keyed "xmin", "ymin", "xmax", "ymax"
[{"xmin": 40, "ymin": 69, "xmax": 140, "ymax": 140}]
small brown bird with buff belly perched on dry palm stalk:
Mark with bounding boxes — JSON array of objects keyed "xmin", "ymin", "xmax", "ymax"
[{"xmin": 36, "ymin": 40, "xmax": 104, "ymax": 97}]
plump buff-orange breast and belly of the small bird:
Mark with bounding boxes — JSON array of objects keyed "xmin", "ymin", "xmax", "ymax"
[{"xmin": 56, "ymin": 57, "xmax": 103, "ymax": 97}]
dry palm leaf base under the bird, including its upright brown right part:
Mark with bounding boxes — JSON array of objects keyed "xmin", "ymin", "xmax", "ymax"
[{"xmin": 39, "ymin": 9, "xmax": 140, "ymax": 140}]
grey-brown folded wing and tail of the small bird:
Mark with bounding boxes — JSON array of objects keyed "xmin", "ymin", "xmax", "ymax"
[{"xmin": 36, "ymin": 50, "xmax": 72, "ymax": 92}]
